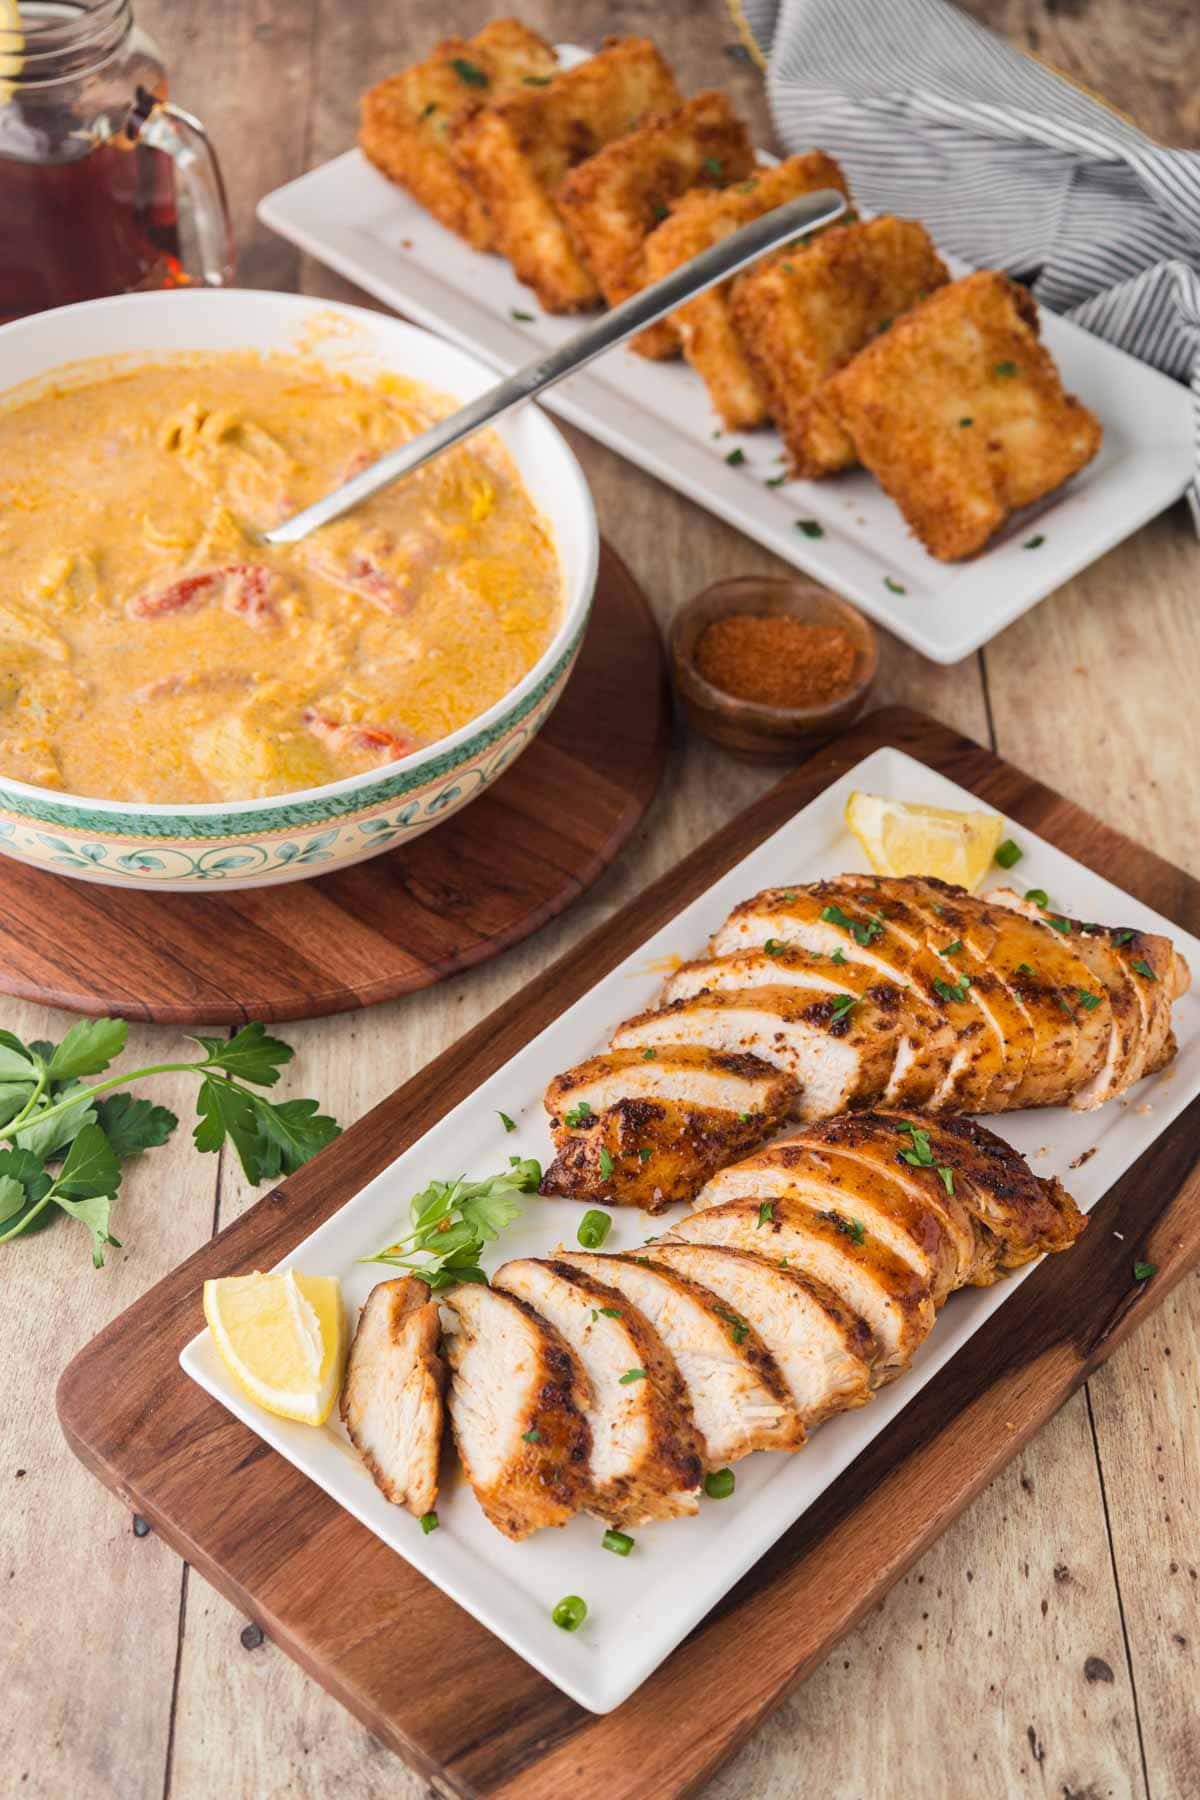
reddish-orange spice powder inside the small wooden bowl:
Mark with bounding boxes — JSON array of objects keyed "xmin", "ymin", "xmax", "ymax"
[{"xmin": 696, "ymin": 612, "xmax": 856, "ymax": 706}]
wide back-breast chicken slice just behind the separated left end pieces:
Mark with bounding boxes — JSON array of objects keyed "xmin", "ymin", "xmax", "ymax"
[{"xmin": 612, "ymin": 986, "xmax": 896, "ymax": 1118}]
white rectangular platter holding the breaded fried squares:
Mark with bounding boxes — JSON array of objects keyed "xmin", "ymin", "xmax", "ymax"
[{"xmin": 259, "ymin": 45, "xmax": 1195, "ymax": 662}]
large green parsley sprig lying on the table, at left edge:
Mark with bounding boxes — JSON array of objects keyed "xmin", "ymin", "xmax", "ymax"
[{"xmin": 0, "ymin": 1019, "xmax": 340, "ymax": 1269}]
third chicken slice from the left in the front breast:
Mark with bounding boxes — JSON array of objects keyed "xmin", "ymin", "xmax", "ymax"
[{"xmin": 493, "ymin": 1256, "xmax": 703, "ymax": 1526}]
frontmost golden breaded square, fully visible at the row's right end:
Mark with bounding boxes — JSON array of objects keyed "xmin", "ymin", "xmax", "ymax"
[{"xmin": 824, "ymin": 270, "xmax": 1101, "ymax": 562}]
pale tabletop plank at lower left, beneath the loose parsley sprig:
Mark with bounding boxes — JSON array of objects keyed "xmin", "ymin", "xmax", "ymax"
[{"xmin": 0, "ymin": 1003, "xmax": 218, "ymax": 1800}]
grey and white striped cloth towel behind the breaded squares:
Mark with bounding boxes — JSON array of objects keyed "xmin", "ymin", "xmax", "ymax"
[{"xmin": 732, "ymin": 0, "xmax": 1200, "ymax": 531}]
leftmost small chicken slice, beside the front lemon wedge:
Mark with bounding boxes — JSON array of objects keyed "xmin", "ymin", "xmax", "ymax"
[{"xmin": 340, "ymin": 1274, "xmax": 446, "ymax": 1517}]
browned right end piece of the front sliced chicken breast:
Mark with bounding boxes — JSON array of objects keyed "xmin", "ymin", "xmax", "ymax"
[{"xmin": 797, "ymin": 1112, "xmax": 1087, "ymax": 1287}]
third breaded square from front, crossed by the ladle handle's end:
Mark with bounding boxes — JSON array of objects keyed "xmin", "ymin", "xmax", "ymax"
[{"xmin": 646, "ymin": 149, "xmax": 849, "ymax": 430}]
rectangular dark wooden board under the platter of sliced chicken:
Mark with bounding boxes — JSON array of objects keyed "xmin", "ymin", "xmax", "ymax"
[{"xmin": 59, "ymin": 707, "xmax": 1200, "ymax": 1800}]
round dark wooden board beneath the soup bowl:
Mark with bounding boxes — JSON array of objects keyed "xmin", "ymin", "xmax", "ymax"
[{"xmin": 0, "ymin": 545, "xmax": 671, "ymax": 1024}]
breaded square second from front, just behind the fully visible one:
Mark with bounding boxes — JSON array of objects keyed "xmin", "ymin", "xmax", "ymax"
[{"xmin": 730, "ymin": 218, "xmax": 950, "ymax": 477}]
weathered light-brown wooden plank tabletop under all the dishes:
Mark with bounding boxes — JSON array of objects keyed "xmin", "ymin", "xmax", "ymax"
[{"xmin": 0, "ymin": 0, "xmax": 1200, "ymax": 1800}]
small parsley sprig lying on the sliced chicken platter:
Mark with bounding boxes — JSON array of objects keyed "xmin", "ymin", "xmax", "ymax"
[{"xmin": 362, "ymin": 1156, "xmax": 542, "ymax": 1289}]
